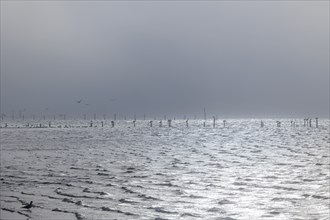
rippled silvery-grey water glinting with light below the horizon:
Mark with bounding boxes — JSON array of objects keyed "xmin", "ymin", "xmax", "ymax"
[{"xmin": 0, "ymin": 119, "xmax": 330, "ymax": 220}]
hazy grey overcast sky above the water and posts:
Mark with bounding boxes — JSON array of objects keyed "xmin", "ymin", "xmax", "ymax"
[{"xmin": 1, "ymin": 1, "xmax": 329, "ymax": 117}]
